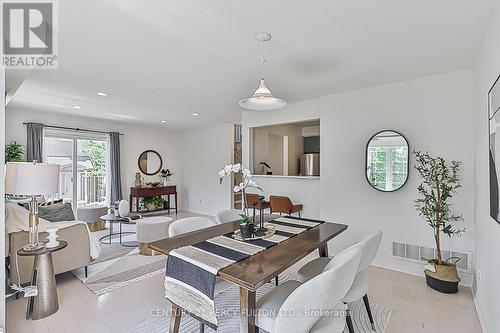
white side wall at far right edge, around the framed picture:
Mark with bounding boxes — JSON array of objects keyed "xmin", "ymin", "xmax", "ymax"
[{"xmin": 474, "ymin": 4, "xmax": 500, "ymax": 333}]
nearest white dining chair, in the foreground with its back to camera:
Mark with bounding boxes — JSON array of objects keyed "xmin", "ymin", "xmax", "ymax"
[{"xmin": 256, "ymin": 248, "xmax": 361, "ymax": 333}]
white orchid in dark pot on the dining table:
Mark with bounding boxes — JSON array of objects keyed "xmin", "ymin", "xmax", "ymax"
[{"xmin": 219, "ymin": 163, "xmax": 262, "ymax": 238}]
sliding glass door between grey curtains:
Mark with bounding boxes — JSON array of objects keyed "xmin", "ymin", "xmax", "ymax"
[{"xmin": 44, "ymin": 129, "xmax": 109, "ymax": 212}]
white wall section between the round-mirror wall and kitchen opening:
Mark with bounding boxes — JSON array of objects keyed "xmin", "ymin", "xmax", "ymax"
[{"xmin": 180, "ymin": 124, "xmax": 234, "ymax": 215}]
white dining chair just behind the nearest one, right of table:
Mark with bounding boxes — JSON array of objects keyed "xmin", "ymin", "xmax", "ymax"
[{"xmin": 297, "ymin": 230, "xmax": 383, "ymax": 333}]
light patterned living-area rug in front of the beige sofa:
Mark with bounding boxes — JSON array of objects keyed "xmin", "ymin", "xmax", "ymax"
[{"xmin": 73, "ymin": 247, "xmax": 166, "ymax": 295}]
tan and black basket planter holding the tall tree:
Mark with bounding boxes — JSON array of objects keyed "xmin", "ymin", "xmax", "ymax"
[{"xmin": 424, "ymin": 259, "xmax": 460, "ymax": 294}]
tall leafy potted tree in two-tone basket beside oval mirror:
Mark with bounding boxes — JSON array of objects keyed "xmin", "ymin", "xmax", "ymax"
[{"xmin": 414, "ymin": 151, "xmax": 465, "ymax": 293}]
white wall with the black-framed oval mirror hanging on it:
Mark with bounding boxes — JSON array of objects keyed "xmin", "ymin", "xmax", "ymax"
[{"xmin": 319, "ymin": 70, "xmax": 474, "ymax": 284}]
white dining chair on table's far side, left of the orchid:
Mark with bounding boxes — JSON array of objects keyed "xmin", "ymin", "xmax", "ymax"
[{"xmin": 168, "ymin": 216, "xmax": 231, "ymax": 333}]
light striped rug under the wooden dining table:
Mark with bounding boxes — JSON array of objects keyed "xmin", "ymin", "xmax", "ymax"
[{"xmin": 128, "ymin": 274, "xmax": 393, "ymax": 333}]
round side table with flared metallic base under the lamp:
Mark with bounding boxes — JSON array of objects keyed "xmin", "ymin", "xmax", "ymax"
[{"xmin": 17, "ymin": 240, "xmax": 68, "ymax": 320}]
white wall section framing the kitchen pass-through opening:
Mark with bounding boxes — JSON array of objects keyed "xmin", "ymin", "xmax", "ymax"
[{"xmin": 242, "ymin": 100, "xmax": 323, "ymax": 218}]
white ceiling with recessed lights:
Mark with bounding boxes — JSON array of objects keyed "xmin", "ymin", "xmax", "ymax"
[{"xmin": 4, "ymin": 0, "xmax": 495, "ymax": 129}]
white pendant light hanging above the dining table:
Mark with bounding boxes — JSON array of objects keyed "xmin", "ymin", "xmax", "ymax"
[{"xmin": 238, "ymin": 32, "xmax": 286, "ymax": 111}]
